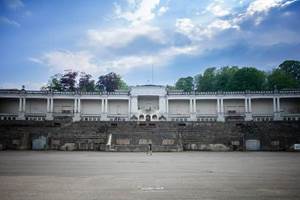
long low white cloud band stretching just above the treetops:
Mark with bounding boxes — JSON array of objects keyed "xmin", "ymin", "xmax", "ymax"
[{"xmin": 28, "ymin": 46, "xmax": 198, "ymax": 77}]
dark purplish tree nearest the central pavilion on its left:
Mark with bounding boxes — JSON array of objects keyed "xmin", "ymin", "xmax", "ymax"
[{"xmin": 97, "ymin": 72, "xmax": 121, "ymax": 92}]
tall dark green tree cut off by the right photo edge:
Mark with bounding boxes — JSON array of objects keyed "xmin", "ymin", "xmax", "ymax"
[{"xmin": 278, "ymin": 60, "xmax": 300, "ymax": 83}]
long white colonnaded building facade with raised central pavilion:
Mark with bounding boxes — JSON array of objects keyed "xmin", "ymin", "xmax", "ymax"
[{"xmin": 0, "ymin": 85, "xmax": 300, "ymax": 122}]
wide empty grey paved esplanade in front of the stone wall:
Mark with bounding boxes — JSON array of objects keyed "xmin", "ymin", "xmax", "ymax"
[{"xmin": 0, "ymin": 152, "xmax": 300, "ymax": 200}]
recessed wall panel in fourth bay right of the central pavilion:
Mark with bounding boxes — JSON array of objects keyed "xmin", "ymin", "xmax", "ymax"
[{"xmin": 251, "ymin": 98, "xmax": 273, "ymax": 115}]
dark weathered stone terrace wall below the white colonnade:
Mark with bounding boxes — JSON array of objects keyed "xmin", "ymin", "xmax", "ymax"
[{"xmin": 0, "ymin": 121, "xmax": 300, "ymax": 151}]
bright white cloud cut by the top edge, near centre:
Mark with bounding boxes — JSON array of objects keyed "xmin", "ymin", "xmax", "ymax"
[{"xmin": 115, "ymin": 0, "xmax": 160, "ymax": 25}]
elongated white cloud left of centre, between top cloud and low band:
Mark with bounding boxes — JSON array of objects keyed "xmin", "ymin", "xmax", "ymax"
[{"xmin": 87, "ymin": 25, "xmax": 165, "ymax": 48}]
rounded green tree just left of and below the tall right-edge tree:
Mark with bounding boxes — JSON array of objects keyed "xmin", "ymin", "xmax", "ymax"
[{"xmin": 268, "ymin": 69, "xmax": 298, "ymax": 90}]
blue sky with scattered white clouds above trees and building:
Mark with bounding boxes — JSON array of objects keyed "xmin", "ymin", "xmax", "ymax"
[{"xmin": 0, "ymin": 0, "xmax": 300, "ymax": 89}]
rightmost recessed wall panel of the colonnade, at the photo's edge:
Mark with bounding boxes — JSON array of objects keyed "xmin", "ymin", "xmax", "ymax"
[{"xmin": 280, "ymin": 98, "xmax": 300, "ymax": 114}]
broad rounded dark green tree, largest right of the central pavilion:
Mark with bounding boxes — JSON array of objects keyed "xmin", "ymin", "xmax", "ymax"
[{"xmin": 229, "ymin": 67, "xmax": 267, "ymax": 91}]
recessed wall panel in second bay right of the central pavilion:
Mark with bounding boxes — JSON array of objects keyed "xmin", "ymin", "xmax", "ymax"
[{"xmin": 196, "ymin": 99, "xmax": 217, "ymax": 115}]
